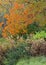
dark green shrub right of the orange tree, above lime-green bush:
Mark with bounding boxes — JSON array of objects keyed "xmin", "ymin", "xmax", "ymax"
[{"xmin": 27, "ymin": 22, "xmax": 41, "ymax": 34}]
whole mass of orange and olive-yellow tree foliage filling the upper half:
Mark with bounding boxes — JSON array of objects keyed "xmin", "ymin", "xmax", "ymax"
[{"xmin": 0, "ymin": 0, "xmax": 46, "ymax": 37}]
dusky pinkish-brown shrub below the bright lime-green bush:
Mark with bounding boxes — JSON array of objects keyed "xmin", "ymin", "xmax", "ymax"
[{"xmin": 29, "ymin": 39, "xmax": 46, "ymax": 56}]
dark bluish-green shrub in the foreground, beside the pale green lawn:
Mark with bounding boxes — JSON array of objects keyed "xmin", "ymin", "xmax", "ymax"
[{"xmin": 3, "ymin": 43, "xmax": 29, "ymax": 65}]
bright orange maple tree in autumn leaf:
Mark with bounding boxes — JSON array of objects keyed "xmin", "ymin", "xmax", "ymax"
[{"xmin": 2, "ymin": 2, "xmax": 33, "ymax": 37}]
